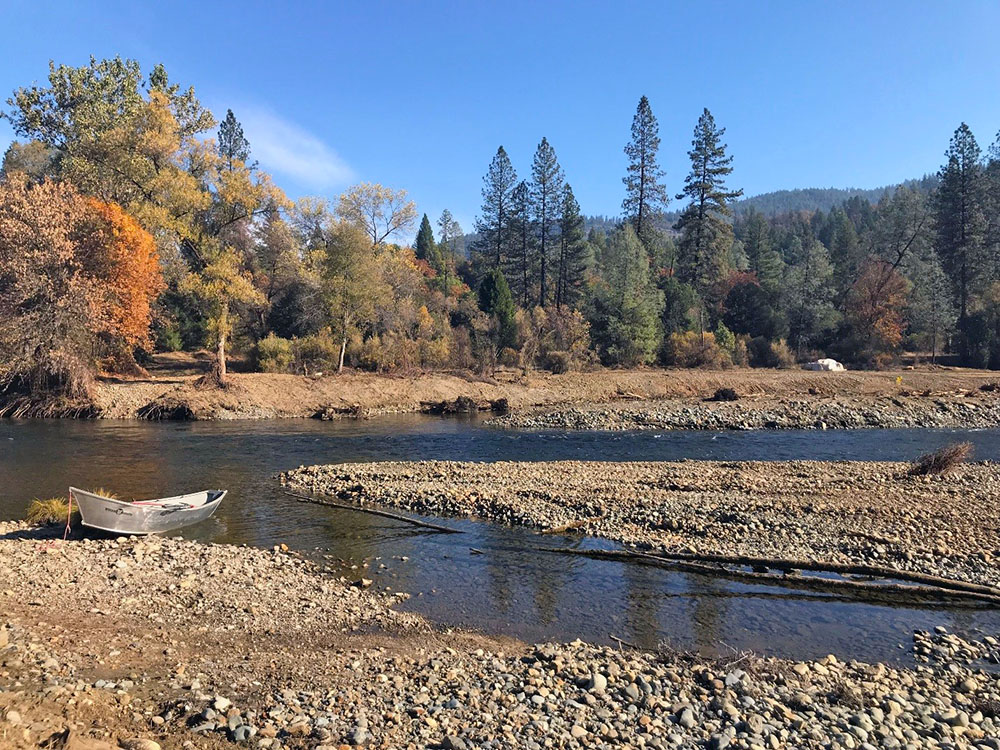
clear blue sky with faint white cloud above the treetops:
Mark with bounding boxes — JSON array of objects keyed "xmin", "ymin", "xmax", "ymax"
[{"xmin": 0, "ymin": 0, "xmax": 1000, "ymax": 235}]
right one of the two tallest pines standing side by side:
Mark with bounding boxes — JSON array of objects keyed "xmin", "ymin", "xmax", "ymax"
[{"xmin": 676, "ymin": 109, "xmax": 743, "ymax": 294}]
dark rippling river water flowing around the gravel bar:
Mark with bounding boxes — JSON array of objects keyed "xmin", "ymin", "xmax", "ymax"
[{"xmin": 0, "ymin": 415, "xmax": 1000, "ymax": 662}]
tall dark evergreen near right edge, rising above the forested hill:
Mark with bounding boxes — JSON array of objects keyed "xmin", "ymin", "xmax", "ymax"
[{"xmin": 934, "ymin": 122, "xmax": 986, "ymax": 323}]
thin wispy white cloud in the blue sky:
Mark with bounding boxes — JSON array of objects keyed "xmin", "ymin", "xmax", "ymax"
[{"xmin": 236, "ymin": 107, "xmax": 355, "ymax": 188}]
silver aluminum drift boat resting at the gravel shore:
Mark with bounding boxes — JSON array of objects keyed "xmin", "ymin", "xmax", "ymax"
[{"xmin": 69, "ymin": 487, "xmax": 226, "ymax": 534}]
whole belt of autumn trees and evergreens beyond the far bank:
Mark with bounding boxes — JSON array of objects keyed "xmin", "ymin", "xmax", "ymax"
[{"xmin": 0, "ymin": 58, "xmax": 1000, "ymax": 412}]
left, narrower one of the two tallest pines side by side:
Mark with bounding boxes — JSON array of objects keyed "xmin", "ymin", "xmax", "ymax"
[{"xmin": 622, "ymin": 96, "xmax": 670, "ymax": 245}]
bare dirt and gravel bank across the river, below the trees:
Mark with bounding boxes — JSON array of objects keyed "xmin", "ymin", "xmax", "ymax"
[{"xmin": 82, "ymin": 362, "xmax": 1000, "ymax": 429}]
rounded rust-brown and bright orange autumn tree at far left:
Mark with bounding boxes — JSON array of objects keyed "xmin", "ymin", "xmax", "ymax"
[{"xmin": 0, "ymin": 174, "xmax": 162, "ymax": 406}]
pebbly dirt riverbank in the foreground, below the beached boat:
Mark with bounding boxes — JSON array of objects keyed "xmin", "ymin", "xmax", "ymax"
[{"xmin": 0, "ymin": 523, "xmax": 1000, "ymax": 750}]
